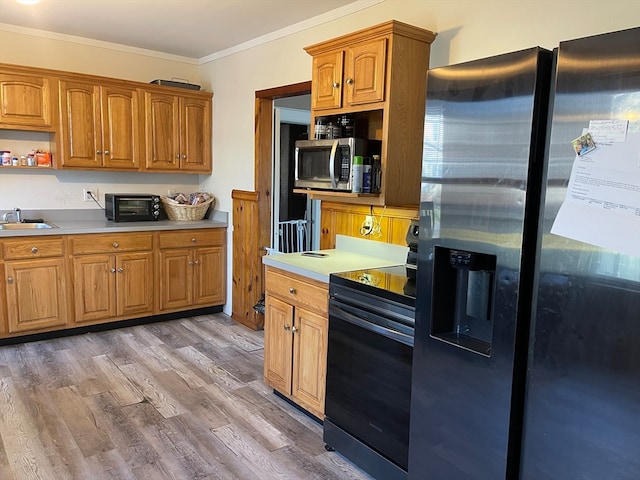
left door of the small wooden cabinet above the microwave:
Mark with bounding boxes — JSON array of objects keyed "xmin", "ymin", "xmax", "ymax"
[{"xmin": 311, "ymin": 50, "xmax": 344, "ymax": 110}]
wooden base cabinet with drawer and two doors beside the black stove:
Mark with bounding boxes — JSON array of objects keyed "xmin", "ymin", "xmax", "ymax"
[{"xmin": 264, "ymin": 267, "xmax": 328, "ymax": 419}]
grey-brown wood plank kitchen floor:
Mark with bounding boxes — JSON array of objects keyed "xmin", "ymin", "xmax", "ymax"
[{"xmin": 0, "ymin": 314, "xmax": 371, "ymax": 480}]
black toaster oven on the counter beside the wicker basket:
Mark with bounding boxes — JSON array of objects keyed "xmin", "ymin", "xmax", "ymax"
[{"xmin": 104, "ymin": 193, "xmax": 166, "ymax": 222}]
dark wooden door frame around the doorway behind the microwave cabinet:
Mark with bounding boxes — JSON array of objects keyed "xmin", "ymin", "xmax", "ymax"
[{"xmin": 256, "ymin": 81, "xmax": 311, "ymax": 264}]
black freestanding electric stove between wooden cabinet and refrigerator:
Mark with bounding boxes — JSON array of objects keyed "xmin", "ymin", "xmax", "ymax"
[{"xmin": 323, "ymin": 265, "xmax": 415, "ymax": 480}]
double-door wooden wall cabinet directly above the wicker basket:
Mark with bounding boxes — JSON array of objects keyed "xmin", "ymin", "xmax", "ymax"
[{"xmin": 144, "ymin": 92, "xmax": 211, "ymax": 173}]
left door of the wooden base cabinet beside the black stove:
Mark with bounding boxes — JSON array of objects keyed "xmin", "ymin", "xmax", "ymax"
[{"xmin": 264, "ymin": 295, "xmax": 293, "ymax": 395}]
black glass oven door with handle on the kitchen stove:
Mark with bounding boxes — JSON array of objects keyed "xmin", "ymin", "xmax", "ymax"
[{"xmin": 325, "ymin": 286, "xmax": 413, "ymax": 471}]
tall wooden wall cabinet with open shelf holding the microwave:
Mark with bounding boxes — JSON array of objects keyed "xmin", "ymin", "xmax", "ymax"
[{"xmin": 305, "ymin": 20, "xmax": 435, "ymax": 206}]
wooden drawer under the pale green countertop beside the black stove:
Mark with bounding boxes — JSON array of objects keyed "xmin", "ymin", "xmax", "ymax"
[{"xmin": 265, "ymin": 269, "xmax": 329, "ymax": 313}]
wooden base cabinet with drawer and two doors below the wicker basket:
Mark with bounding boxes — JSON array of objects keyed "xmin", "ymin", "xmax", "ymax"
[{"xmin": 158, "ymin": 229, "xmax": 226, "ymax": 312}]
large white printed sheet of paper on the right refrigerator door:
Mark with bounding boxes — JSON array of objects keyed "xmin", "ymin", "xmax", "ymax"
[{"xmin": 551, "ymin": 128, "xmax": 640, "ymax": 256}]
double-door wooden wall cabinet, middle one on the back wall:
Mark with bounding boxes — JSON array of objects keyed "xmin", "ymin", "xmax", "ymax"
[{"xmin": 58, "ymin": 80, "xmax": 140, "ymax": 170}]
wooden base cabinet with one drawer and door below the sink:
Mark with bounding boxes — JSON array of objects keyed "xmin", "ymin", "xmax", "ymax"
[{"xmin": 0, "ymin": 237, "xmax": 67, "ymax": 334}]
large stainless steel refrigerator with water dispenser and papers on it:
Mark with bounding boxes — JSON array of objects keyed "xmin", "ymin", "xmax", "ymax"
[{"xmin": 408, "ymin": 28, "xmax": 640, "ymax": 480}]
